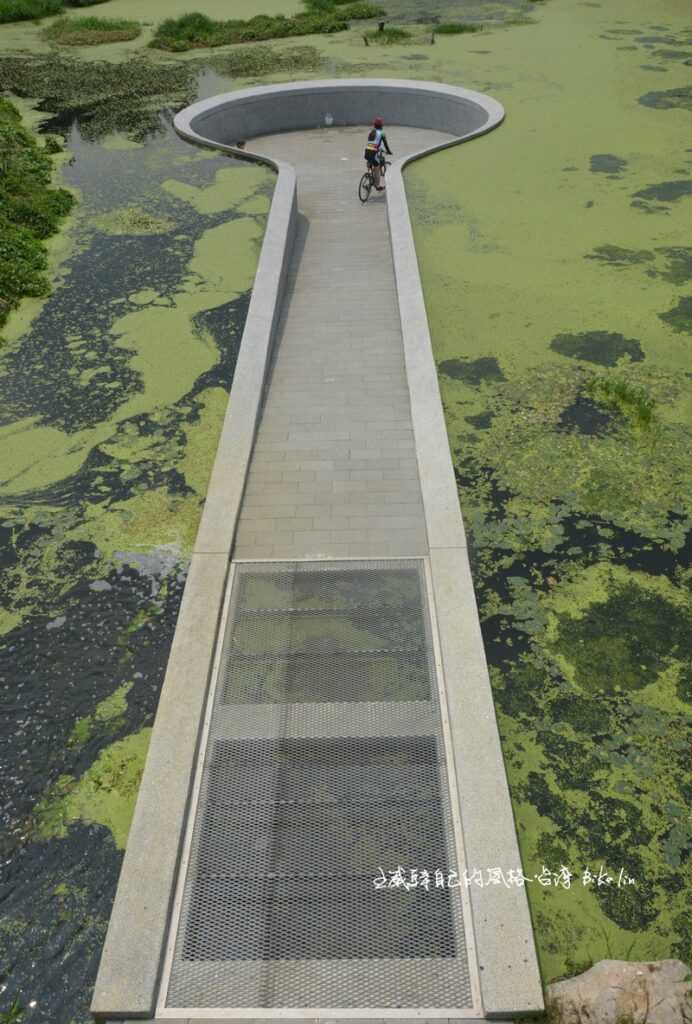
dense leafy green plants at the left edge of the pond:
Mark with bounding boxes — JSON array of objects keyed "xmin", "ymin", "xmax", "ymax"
[{"xmin": 0, "ymin": 98, "xmax": 74, "ymax": 326}]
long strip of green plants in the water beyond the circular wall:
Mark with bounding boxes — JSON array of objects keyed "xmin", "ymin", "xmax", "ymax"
[{"xmin": 149, "ymin": 2, "xmax": 382, "ymax": 52}]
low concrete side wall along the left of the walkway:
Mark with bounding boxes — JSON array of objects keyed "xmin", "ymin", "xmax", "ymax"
[{"xmin": 91, "ymin": 144, "xmax": 297, "ymax": 1018}]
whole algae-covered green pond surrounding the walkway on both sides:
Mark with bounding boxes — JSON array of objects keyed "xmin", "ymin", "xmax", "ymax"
[{"xmin": 0, "ymin": 0, "xmax": 692, "ymax": 1024}]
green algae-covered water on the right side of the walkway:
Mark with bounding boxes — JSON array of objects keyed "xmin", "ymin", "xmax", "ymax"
[{"xmin": 399, "ymin": 0, "xmax": 692, "ymax": 982}]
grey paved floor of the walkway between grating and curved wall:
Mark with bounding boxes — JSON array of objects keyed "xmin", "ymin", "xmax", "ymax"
[{"xmin": 231, "ymin": 127, "xmax": 449, "ymax": 559}]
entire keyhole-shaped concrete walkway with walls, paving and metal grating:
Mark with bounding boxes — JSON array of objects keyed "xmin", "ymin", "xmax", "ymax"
[{"xmin": 92, "ymin": 83, "xmax": 542, "ymax": 1024}]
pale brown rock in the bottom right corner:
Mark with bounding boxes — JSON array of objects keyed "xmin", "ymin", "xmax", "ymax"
[{"xmin": 547, "ymin": 961, "xmax": 692, "ymax": 1024}]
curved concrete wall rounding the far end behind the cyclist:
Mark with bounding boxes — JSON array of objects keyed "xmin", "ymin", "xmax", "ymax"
[{"xmin": 181, "ymin": 79, "xmax": 503, "ymax": 145}]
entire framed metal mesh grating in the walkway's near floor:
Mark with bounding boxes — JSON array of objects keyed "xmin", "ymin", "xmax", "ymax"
[{"xmin": 166, "ymin": 561, "xmax": 471, "ymax": 1010}]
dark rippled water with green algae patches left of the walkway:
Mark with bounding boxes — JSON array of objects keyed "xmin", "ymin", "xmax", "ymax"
[{"xmin": 0, "ymin": 88, "xmax": 273, "ymax": 1024}]
